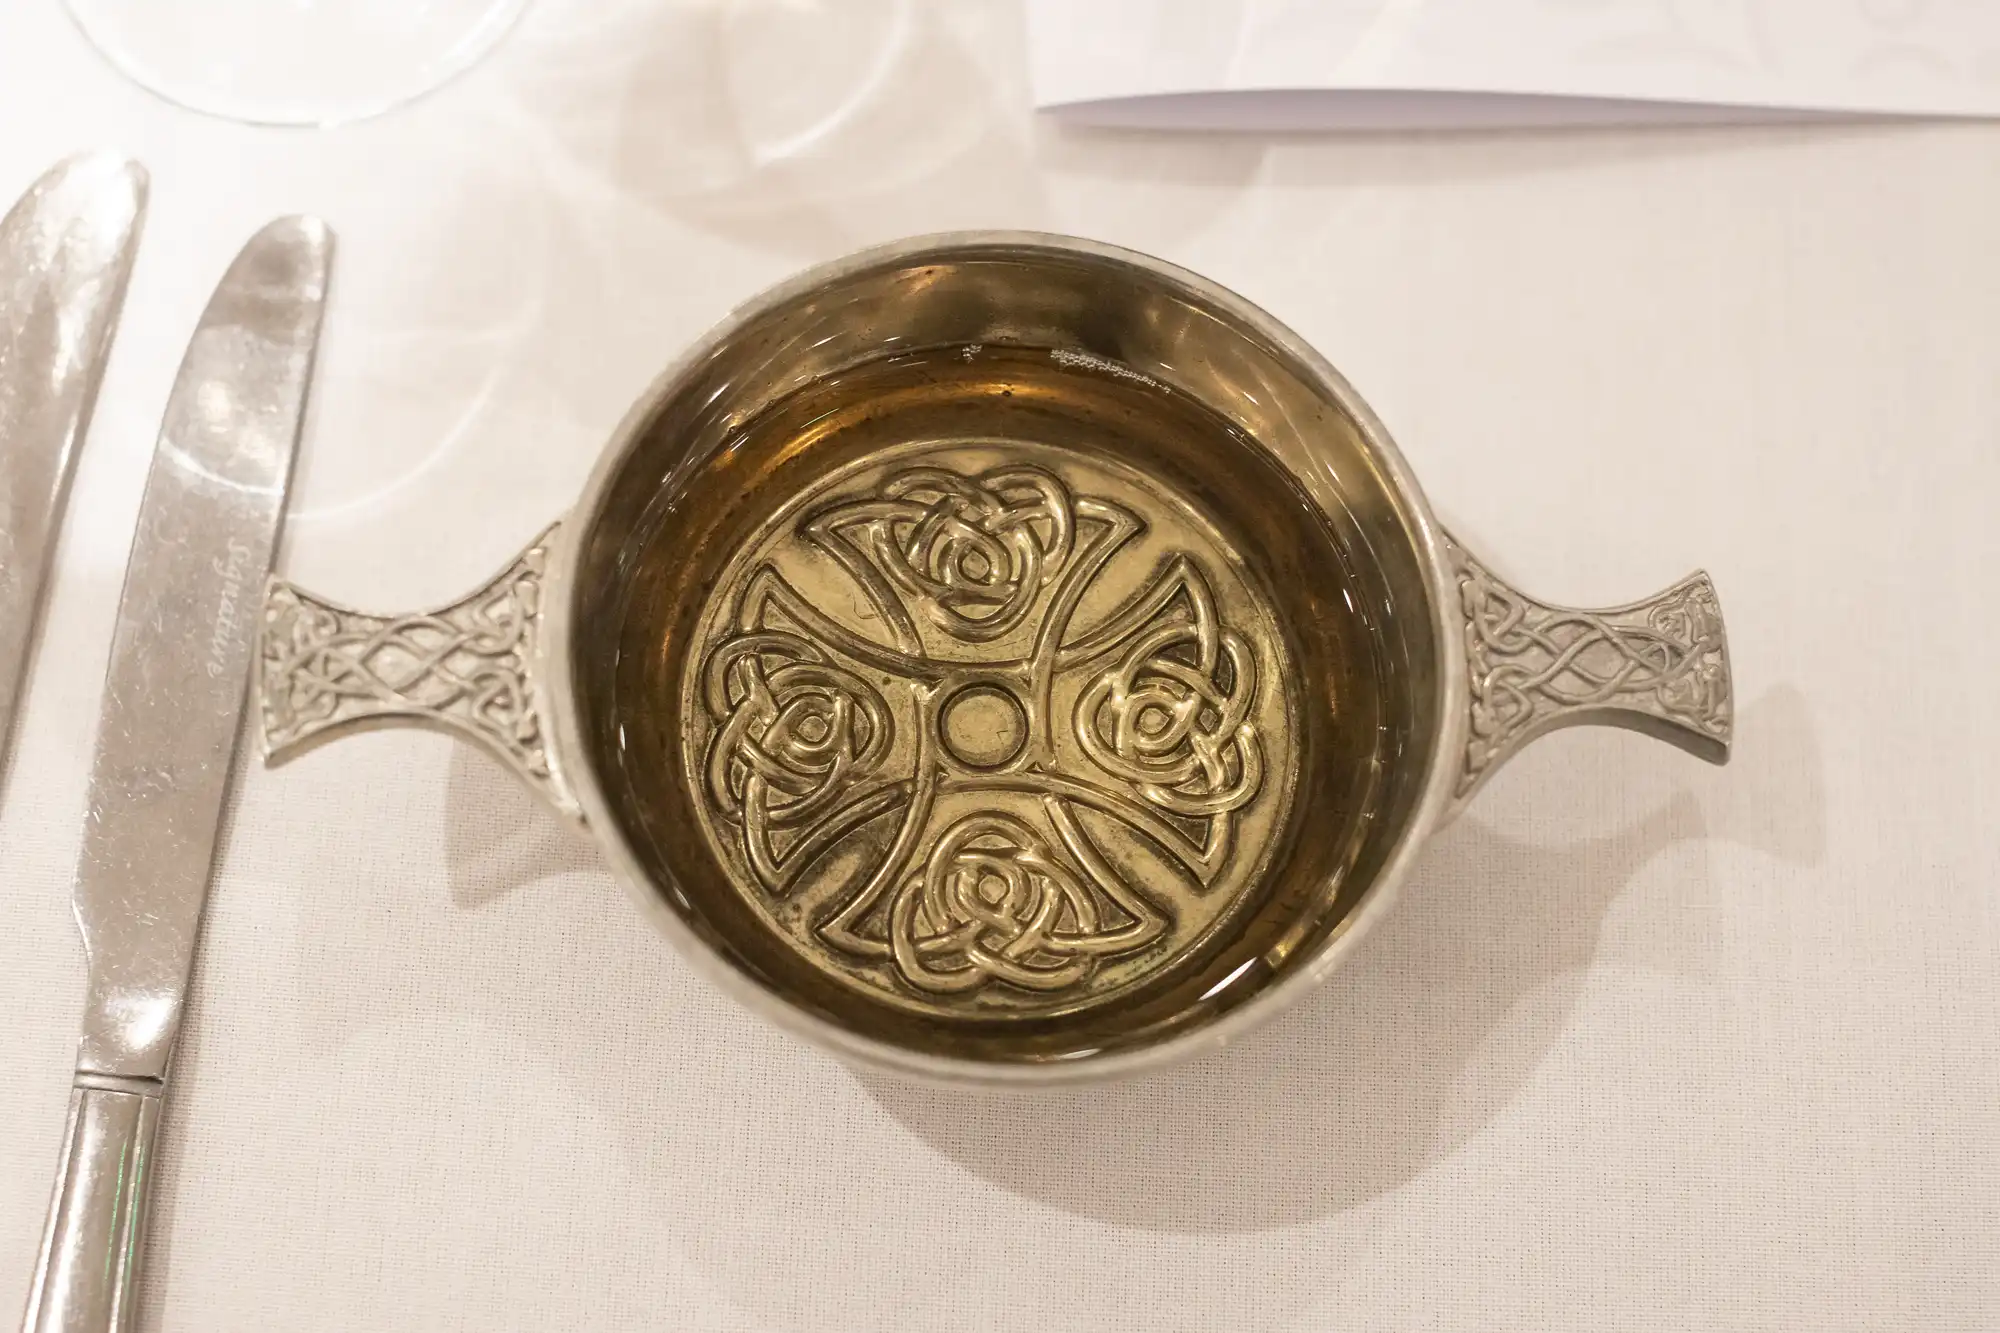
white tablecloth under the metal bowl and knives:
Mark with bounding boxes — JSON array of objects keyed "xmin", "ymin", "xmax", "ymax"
[{"xmin": 0, "ymin": 0, "xmax": 2000, "ymax": 1333}]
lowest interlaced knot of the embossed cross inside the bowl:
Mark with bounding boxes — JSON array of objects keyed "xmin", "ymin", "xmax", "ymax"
[{"xmin": 890, "ymin": 813, "xmax": 1162, "ymax": 993}]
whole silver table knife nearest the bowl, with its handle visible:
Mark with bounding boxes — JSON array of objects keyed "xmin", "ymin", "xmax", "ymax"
[{"xmin": 24, "ymin": 218, "xmax": 332, "ymax": 1333}]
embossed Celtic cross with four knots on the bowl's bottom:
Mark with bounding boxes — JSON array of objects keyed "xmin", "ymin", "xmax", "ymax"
[{"xmin": 684, "ymin": 446, "xmax": 1270, "ymax": 1011}]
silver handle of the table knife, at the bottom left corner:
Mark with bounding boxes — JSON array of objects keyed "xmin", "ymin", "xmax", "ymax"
[{"xmin": 22, "ymin": 1075, "xmax": 162, "ymax": 1333}]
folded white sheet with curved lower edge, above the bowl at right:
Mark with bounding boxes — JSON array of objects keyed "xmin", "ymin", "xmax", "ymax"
[{"xmin": 1028, "ymin": 0, "xmax": 2000, "ymax": 130}]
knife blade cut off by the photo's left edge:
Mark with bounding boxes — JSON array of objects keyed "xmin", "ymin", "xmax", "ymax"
[{"xmin": 0, "ymin": 154, "xmax": 146, "ymax": 769}]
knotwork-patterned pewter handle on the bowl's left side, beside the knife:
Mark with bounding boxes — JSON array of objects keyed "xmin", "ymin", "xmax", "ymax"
[{"xmin": 258, "ymin": 524, "xmax": 582, "ymax": 823}]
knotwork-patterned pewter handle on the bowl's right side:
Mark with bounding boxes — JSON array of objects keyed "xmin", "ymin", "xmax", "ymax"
[{"xmin": 1444, "ymin": 534, "xmax": 1734, "ymax": 813}]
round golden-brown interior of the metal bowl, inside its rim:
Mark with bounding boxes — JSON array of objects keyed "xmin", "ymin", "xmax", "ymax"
[{"xmin": 568, "ymin": 240, "xmax": 1440, "ymax": 1063}]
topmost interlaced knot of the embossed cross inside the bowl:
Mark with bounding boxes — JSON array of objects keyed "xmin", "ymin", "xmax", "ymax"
[{"xmin": 808, "ymin": 468, "xmax": 1074, "ymax": 642}]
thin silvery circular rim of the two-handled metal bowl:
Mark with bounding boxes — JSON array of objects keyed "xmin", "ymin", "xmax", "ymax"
[{"xmin": 536, "ymin": 230, "xmax": 1470, "ymax": 1087}]
